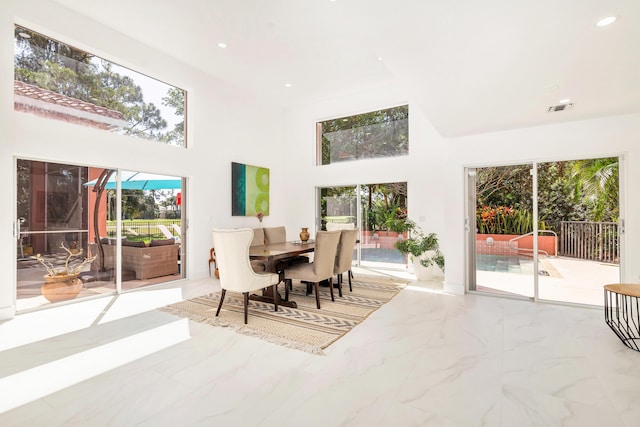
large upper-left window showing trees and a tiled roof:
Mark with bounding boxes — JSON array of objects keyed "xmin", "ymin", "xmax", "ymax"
[{"xmin": 14, "ymin": 26, "xmax": 186, "ymax": 147}]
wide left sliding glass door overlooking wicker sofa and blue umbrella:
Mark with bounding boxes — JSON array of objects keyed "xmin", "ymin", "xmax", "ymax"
[{"xmin": 16, "ymin": 159, "xmax": 185, "ymax": 311}]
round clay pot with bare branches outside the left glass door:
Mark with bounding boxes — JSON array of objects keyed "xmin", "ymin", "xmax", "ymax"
[{"xmin": 35, "ymin": 242, "xmax": 96, "ymax": 302}]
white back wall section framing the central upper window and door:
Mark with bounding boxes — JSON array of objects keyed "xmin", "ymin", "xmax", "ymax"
[{"xmin": 285, "ymin": 85, "xmax": 448, "ymax": 278}]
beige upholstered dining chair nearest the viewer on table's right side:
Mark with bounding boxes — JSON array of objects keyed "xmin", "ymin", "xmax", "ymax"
[{"xmin": 284, "ymin": 231, "xmax": 340, "ymax": 308}]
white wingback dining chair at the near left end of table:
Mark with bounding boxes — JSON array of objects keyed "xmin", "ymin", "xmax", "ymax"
[{"xmin": 212, "ymin": 228, "xmax": 280, "ymax": 324}]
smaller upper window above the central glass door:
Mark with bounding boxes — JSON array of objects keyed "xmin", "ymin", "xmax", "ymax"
[{"xmin": 316, "ymin": 105, "xmax": 409, "ymax": 165}]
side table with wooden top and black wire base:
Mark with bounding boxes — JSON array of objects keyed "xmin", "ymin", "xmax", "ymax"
[{"xmin": 604, "ymin": 283, "xmax": 640, "ymax": 351}]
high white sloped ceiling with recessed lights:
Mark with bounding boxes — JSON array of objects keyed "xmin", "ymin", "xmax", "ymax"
[{"xmin": 55, "ymin": 0, "xmax": 640, "ymax": 136}]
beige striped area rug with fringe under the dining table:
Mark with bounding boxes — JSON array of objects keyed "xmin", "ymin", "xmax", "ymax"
[{"xmin": 160, "ymin": 276, "xmax": 408, "ymax": 354}]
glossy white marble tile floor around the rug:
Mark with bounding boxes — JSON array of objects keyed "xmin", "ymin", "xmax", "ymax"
[{"xmin": 0, "ymin": 269, "xmax": 640, "ymax": 427}]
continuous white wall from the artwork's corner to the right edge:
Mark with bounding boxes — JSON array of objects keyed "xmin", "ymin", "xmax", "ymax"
[{"xmin": 285, "ymin": 87, "xmax": 640, "ymax": 293}]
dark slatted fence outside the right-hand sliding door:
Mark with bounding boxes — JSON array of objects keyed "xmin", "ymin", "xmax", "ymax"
[{"xmin": 559, "ymin": 221, "xmax": 620, "ymax": 264}]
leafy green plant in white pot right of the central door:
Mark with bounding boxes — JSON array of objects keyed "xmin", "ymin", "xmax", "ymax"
[{"xmin": 394, "ymin": 224, "xmax": 444, "ymax": 281}]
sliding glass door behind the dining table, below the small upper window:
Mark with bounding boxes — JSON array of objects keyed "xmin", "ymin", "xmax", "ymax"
[{"xmin": 318, "ymin": 182, "xmax": 407, "ymax": 268}]
